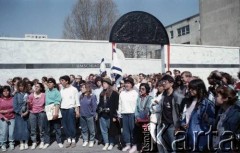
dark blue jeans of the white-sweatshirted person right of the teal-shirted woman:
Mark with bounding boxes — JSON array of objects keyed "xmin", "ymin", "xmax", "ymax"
[{"xmin": 61, "ymin": 108, "xmax": 76, "ymax": 139}]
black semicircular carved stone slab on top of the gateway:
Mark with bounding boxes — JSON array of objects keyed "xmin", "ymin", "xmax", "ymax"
[{"xmin": 109, "ymin": 11, "xmax": 169, "ymax": 45}]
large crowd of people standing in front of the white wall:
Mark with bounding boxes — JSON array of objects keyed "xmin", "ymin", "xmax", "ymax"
[{"xmin": 0, "ymin": 70, "xmax": 240, "ymax": 153}]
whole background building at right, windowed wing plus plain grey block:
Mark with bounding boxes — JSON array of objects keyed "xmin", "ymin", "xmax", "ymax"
[{"xmin": 166, "ymin": 0, "xmax": 240, "ymax": 47}]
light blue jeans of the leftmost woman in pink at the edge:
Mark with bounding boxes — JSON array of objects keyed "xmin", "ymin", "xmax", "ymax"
[{"xmin": 0, "ymin": 119, "xmax": 15, "ymax": 145}]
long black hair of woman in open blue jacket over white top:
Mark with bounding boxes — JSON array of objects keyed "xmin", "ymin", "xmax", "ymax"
[{"xmin": 188, "ymin": 79, "xmax": 207, "ymax": 101}]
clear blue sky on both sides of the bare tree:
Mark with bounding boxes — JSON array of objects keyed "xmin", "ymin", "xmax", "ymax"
[{"xmin": 0, "ymin": 0, "xmax": 199, "ymax": 38}]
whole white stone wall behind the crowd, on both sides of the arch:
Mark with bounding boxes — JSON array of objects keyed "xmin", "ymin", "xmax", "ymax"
[{"xmin": 0, "ymin": 38, "xmax": 240, "ymax": 84}]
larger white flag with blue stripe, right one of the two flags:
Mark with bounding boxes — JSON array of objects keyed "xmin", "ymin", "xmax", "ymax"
[{"xmin": 111, "ymin": 47, "xmax": 123, "ymax": 85}]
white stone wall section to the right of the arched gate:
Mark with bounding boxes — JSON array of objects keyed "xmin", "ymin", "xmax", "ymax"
[{"xmin": 165, "ymin": 44, "xmax": 240, "ymax": 83}]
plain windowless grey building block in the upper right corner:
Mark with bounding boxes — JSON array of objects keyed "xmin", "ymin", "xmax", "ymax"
[{"xmin": 199, "ymin": 0, "xmax": 240, "ymax": 47}]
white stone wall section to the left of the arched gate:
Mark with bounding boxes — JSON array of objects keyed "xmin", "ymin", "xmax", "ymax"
[{"xmin": 0, "ymin": 38, "xmax": 112, "ymax": 84}]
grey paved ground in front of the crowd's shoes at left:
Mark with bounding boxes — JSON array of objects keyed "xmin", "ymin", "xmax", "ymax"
[{"xmin": 4, "ymin": 140, "xmax": 122, "ymax": 153}]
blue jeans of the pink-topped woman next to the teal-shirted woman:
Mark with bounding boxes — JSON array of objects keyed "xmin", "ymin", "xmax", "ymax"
[{"xmin": 29, "ymin": 112, "xmax": 47, "ymax": 143}]
